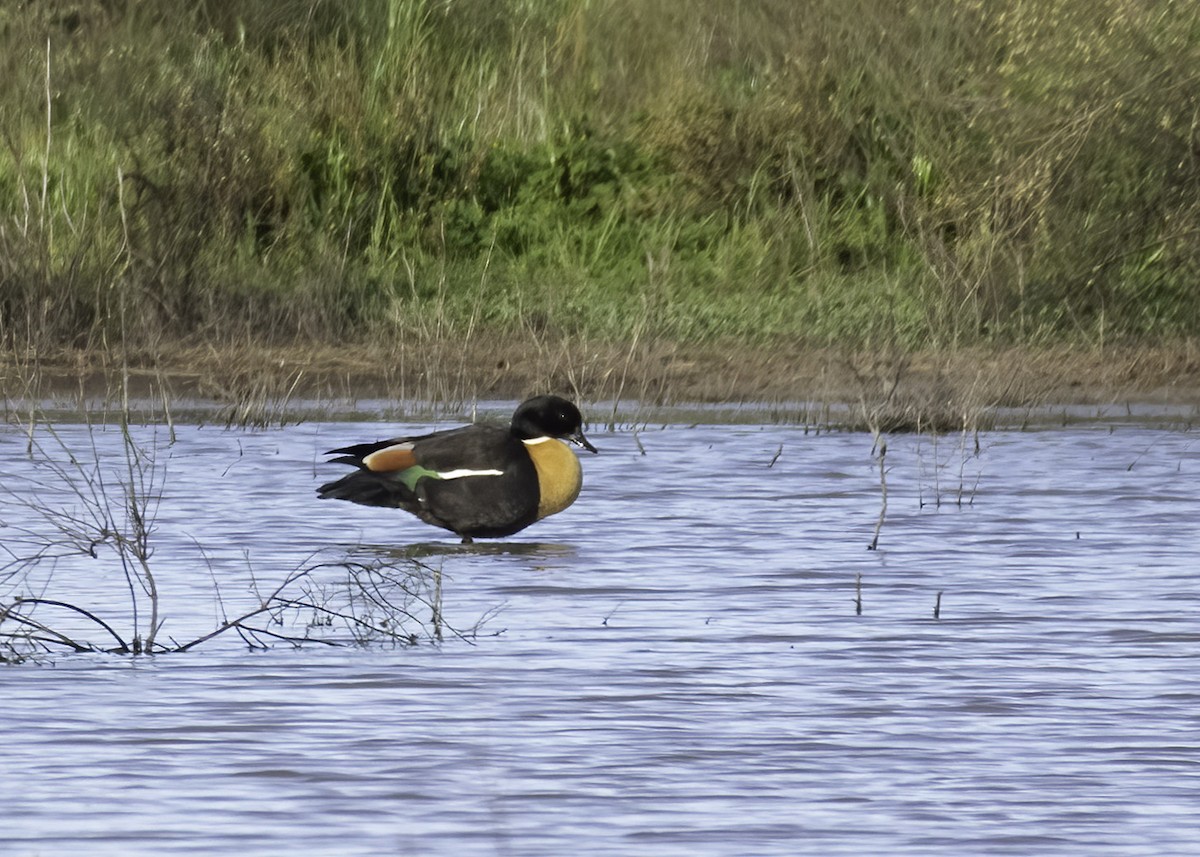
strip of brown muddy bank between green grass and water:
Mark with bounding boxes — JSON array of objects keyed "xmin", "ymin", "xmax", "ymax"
[{"xmin": 0, "ymin": 338, "xmax": 1200, "ymax": 419}]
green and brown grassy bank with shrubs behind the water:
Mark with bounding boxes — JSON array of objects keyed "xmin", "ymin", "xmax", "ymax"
[{"xmin": 0, "ymin": 0, "xmax": 1200, "ymax": 366}]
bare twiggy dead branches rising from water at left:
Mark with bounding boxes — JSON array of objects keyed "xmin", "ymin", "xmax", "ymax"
[{"xmin": 0, "ymin": 396, "xmax": 488, "ymax": 663}]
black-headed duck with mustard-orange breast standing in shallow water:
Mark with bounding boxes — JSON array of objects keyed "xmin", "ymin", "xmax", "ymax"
[{"xmin": 317, "ymin": 396, "xmax": 598, "ymax": 544}]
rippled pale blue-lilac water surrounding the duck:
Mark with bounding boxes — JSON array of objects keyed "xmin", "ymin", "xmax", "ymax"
[{"xmin": 0, "ymin": 410, "xmax": 1200, "ymax": 857}]
